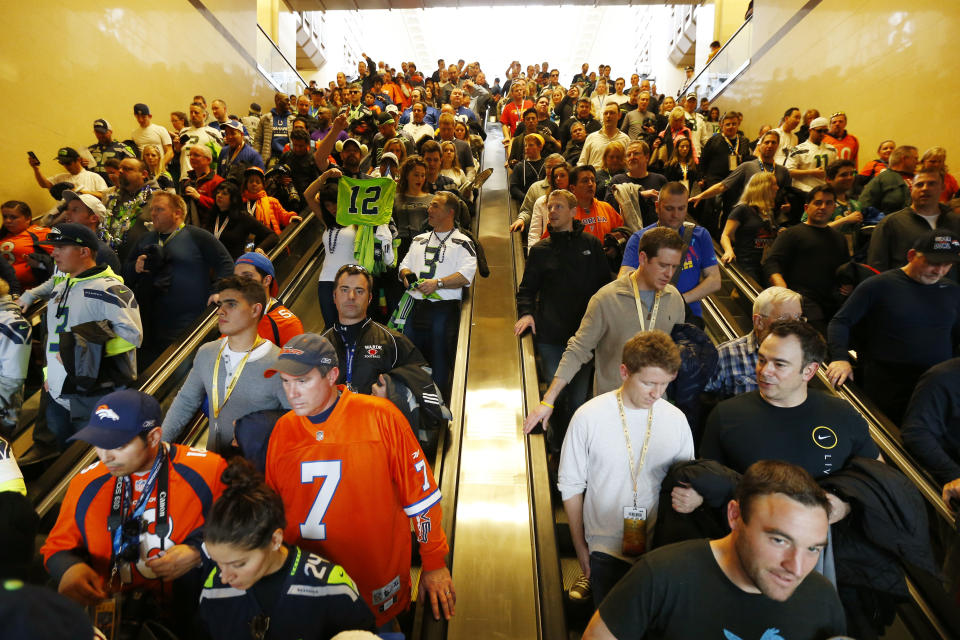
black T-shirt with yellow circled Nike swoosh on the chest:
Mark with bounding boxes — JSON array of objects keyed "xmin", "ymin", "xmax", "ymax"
[{"xmin": 700, "ymin": 390, "xmax": 880, "ymax": 478}]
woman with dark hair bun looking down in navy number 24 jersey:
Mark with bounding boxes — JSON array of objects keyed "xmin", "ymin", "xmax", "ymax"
[{"xmin": 198, "ymin": 457, "xmax": 373, "ymax": 640}]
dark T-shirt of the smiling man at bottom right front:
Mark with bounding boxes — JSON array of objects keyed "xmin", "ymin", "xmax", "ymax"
[{"xmin": 600, "ymin": 540, "xmax": 846, "ymax": 640}]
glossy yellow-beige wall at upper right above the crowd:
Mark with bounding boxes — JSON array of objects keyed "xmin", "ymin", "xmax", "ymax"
[{"xmin": 715, "ymin": 0, "xmax": 960, "ymax": 167}]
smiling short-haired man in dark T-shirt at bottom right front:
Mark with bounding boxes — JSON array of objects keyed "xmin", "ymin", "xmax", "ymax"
[{"xmin": 583, "ymin": 461, "xmax": 845, "ymax": 640}]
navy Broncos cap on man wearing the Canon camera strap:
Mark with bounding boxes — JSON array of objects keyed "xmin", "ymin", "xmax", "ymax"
[{"xmin": 67, "ymin": 389, "xmax": 163, "ymax": 449}]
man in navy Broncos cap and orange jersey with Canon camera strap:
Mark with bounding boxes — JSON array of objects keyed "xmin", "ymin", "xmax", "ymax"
[{"xmin": 40, "ymin": 389, "xmax": 226, "ymax": 632}]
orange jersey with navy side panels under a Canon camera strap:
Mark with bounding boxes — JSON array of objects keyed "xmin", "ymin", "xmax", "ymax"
[{"xmin": 40, "ymin": 444, "xmax": 227, "ymax": 589}]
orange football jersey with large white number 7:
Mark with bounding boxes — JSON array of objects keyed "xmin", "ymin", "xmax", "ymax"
[{"xmin": 266, "ymin": 386, "xmax": 448, "ymax": 626}]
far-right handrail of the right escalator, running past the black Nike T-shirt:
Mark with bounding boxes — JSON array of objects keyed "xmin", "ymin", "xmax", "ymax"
[{"xmin": 714, "ymin": 248, "xmax": 957, "ymax": 529}]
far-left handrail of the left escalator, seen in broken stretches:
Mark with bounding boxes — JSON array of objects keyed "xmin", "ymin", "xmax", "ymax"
[{"xmin": 35, "ymin": 212, "xmax": 314, "ymax": 518}]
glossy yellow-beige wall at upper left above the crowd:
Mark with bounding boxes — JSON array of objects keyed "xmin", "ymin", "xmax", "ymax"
[{"xmin": 0, "ymin": 0, "xmax": 273, "ymax": 212}]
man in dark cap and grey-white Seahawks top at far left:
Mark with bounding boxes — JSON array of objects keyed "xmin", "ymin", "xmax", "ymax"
[{"xmin": 41, "ymin": 223, "xmax": 143, "ymax": 449}]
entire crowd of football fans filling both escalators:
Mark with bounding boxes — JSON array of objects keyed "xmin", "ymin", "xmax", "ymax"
[{"xmin": 0, "ymin": 54, "xmax": 960, "ymax": 638}]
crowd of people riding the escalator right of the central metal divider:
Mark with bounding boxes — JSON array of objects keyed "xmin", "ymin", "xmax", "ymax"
[{"xmin": 500, "ymin": 60, "xmax": 960, "ymax": 638}]
